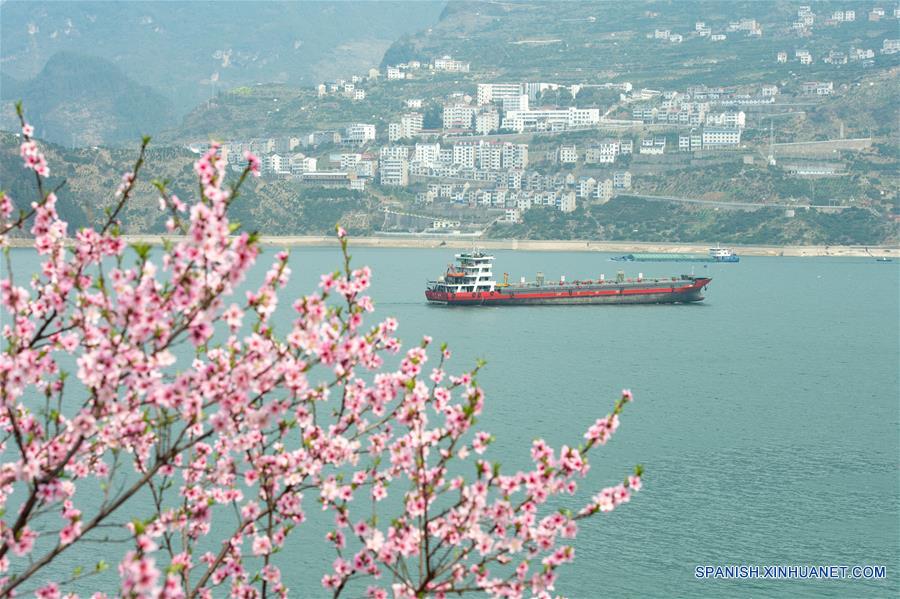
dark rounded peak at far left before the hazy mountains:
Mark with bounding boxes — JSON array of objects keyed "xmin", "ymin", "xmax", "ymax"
[{"xmin": 3, "ymin": 52, "xmax": 175, "ymax": 146}]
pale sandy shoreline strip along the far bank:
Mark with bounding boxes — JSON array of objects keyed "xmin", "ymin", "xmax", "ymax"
[{"xmin": 3, "ymin": 234, "xmax": 900, "ymax": 258}]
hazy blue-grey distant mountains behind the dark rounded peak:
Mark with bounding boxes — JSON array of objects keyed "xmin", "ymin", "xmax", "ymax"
[{"xmin": 0, "ymin": 1, "xmax": 444, "ymax": 114}]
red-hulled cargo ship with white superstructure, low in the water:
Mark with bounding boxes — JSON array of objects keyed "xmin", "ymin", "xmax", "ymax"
[{"xmin": 425, "ymin": 250, "xmax": 712, "ymax": 306}]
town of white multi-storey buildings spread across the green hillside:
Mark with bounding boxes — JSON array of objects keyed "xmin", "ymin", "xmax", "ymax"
[{"xmin": 190, "ymin": 6, "xmax": 900, "ymax": 230}]
